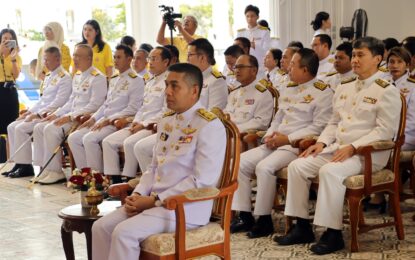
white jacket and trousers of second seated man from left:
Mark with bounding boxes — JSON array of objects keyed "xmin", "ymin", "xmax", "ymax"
[{"xmin": 33, "ymin": 66, "xmax": 107, "ymax": 172}]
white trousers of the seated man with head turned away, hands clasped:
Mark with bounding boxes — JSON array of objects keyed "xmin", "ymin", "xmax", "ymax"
[{"xmin": 232, "ymin": 144, "xmax": 297, "ymax": 216}]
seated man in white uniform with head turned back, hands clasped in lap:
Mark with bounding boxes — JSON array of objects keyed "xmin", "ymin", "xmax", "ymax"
[{"xmin": 231, "ymin": 48, "xmax": 333, "ymax": 238}]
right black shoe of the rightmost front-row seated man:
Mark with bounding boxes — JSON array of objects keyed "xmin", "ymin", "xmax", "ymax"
[{"xmin": 310, "ymin": 230, "xmax": 344, "ymax": 255}]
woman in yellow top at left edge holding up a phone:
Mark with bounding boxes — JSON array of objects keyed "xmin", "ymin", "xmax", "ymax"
[{"xmin": 0, "ymin": 29, "xmax": 22, "ymax": 134}]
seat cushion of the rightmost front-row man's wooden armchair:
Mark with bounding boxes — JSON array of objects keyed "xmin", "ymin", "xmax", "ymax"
[{"xmin": 343, "ymin": 169, "xmax": 395, "ymax": 190}]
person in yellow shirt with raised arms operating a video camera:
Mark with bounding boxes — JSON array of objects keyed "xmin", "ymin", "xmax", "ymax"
[{"xmin": 157, "ymin": 15, "xmax": 201, "ymax": 62}]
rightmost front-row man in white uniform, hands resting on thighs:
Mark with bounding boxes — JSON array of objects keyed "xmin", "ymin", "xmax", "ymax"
[{"xmin": 275, "ymin": 37, "xmax": 401, "ymax": 255}]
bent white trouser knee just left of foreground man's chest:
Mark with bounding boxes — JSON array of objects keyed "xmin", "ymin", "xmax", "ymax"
[{"xmin": 134, "ymin": 134, "xmax": 157, "ymax": 175}]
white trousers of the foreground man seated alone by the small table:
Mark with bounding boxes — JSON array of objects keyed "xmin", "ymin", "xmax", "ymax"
[{"xmin": 92, "ymin": 207, "xmax": 198, "ymax": 260}]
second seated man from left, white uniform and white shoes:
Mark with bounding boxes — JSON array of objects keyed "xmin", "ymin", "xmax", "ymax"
[{"xmin": 33, "ymin": 44, "xmax": 107, "ymax": 184}]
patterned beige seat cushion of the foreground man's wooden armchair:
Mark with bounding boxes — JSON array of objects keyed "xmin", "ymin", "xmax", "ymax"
[{"xmin": 141, "ymin": 222, "xmax": 224, "ymax": 256}]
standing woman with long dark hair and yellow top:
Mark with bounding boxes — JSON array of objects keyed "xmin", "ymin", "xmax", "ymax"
[{"xmin": 75, "ymin": 20, "xmax": 114, "ymax": 78}]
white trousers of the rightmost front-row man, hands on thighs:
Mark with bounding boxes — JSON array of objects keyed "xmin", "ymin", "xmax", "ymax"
[{"xmin": 284, "ymin": 153, "xmax": 386, "ymax": 229}]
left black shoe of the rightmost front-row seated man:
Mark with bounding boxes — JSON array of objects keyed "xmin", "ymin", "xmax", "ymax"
[{"xmin": 274, "ymin": 224, "xmax": 315, "ymax": 246}]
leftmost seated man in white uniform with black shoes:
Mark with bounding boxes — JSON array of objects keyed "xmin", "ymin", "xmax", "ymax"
[{"xmin": 3, "ymin": 47, "xmax": 72, "ymax": 178}]
